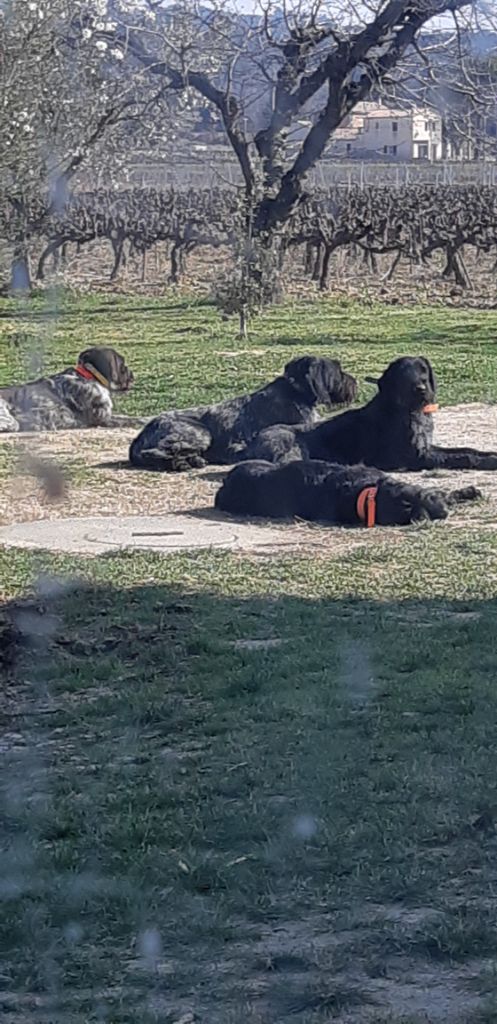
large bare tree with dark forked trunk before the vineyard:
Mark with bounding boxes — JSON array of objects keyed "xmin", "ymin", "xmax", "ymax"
[{"xmin": 88, "ymin": 0, "xmax": 493, "ymax": 236}]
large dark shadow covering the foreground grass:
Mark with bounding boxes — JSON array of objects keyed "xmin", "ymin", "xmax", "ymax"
[{"xmin": 0, "ymin": 573, "xmax": 497, "ymax": 1024}]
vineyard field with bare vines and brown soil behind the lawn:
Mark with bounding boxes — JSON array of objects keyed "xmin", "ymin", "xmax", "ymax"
[{"xmin": 7, "ymin": 183, "xmax": 497, "ymax": 309}]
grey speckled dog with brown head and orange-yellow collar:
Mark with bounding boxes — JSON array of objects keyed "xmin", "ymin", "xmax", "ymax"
[{"xmin": 0, "ymin": 348, "xmax": 137, "ymax": 432}]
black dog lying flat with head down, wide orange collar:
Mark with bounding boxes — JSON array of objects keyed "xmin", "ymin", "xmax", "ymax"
[{"xmin": 215, "ymin": 461, "xmax": 481, "ymax": 526}]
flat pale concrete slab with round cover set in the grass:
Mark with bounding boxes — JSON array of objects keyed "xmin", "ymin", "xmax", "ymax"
[{"xmin": 0, "ymin": 514, "xmax": 295, "ymax": 555}]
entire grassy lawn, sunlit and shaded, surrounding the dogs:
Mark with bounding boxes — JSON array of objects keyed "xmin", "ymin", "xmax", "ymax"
[{"xmin": 0, "ymin": 293, "xmax": 497, "ymax": 1024}]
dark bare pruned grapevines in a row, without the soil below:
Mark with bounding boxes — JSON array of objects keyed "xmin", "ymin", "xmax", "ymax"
[{"xmin": 0, "ymin": 185, "xmax": 497, "ymax": 288}]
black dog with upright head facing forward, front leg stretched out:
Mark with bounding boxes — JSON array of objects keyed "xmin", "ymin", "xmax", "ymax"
[{"xmin": 245, "ymin": 357, "xmax": 497, "ymax": 470}]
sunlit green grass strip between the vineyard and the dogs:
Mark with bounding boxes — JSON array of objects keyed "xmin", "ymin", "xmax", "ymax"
[{"xmin": 0, "ymin": 293, "xmax": 497, "ymax": 414}]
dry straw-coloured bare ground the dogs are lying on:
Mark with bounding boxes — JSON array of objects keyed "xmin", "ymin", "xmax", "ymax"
[{"xmin": 0, "ymin": 404, "xmax": 497, "ymax": 557}]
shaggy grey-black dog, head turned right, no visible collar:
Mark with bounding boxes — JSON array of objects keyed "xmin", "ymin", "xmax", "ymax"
[{"xmin": 129, "ymin": 355, "xmax": 357, "ymax": 472}]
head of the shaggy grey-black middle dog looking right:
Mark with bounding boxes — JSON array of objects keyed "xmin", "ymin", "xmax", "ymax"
[{"xmin": 284, "ymin": 355, "xmax": 358, "ymax": 408}]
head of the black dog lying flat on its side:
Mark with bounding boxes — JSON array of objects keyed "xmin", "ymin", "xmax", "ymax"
[{"xmin": 376, "ymin": 479, "xmax": 449, "ymax": 526}]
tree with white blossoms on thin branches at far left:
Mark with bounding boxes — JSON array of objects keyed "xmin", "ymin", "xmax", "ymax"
[{"xmin": 0, "ymin": 0, "xmax": 176, "ymax": 289}]
